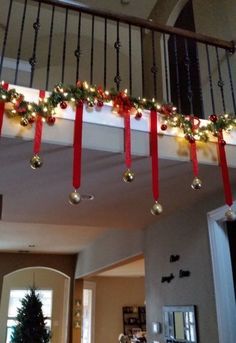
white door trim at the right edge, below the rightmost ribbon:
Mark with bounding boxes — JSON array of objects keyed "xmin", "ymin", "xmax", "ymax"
[{"xmin": 207, "ymin": 206, "xmax": 236, "ymax": 343}]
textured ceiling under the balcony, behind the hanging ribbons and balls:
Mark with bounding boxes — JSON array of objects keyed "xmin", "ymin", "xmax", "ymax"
[{"xmin": 0, "ymin": 138, "xmax": 236, "ymax": 252}]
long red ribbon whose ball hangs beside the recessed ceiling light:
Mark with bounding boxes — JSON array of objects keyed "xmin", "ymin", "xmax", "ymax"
[{"xmin": 73, "ymin": 102, "xmax": 83, "ymax": 189}]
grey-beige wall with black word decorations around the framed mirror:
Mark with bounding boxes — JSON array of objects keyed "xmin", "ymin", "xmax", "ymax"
[{"xmin": 145, "ymin": 197, "xmax": 218, "ymax": 343}]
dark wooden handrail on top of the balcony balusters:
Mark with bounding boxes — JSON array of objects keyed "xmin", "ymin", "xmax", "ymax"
[{"xmin": 33, "ymin": 0, "xmax": 235, "ymax": 53}]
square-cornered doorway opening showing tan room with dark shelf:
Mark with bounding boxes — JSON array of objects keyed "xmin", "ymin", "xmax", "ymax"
[{"xmin": 82, "ymin": 256, "xmax": 146, "ymax": 343}]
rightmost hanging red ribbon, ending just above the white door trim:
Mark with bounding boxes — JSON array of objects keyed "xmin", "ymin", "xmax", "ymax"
[{"xmin": 218, "ymin": 130, "xmax": 233, "ymax": 206}]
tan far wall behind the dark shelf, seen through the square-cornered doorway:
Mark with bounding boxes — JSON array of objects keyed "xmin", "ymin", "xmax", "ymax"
[{"xmin": 89, "ymin": 277, "xmax": 145, "ymax": 343}]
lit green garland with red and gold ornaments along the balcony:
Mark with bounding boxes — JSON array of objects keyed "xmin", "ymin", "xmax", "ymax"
[{"xmin": 0, "ymin": 81, "xmax": 236, "ymax": 143}]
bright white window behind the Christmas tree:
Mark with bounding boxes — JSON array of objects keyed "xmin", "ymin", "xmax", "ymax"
[{"xmin": 6, "ymin": 289, "xmax": 52, "ymax": 343}]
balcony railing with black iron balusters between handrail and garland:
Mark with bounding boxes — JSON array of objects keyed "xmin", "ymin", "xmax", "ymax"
[{"xmin": 0, "ymin": 0, "xmax": 236, "ymax": 117}]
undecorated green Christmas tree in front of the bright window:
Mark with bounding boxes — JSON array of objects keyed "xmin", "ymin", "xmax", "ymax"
[{"xmin": 11, "ymin": 288, "xmax": 51, "ymax": 343}]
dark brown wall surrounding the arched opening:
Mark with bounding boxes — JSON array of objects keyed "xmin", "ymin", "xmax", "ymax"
[{"xmin": 0, "ymin": 253, "xmax": 76, "ymax": 343}]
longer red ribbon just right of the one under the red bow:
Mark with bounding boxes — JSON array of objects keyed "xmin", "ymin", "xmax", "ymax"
[{"xmin": 150, "ymin": 110, "xmax": 159, "ymax": 201}]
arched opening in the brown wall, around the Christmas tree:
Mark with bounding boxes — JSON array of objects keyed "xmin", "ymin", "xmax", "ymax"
[{"xmin": 0, "ymin": 267, "xmax": 70, "ymax": 343}]
